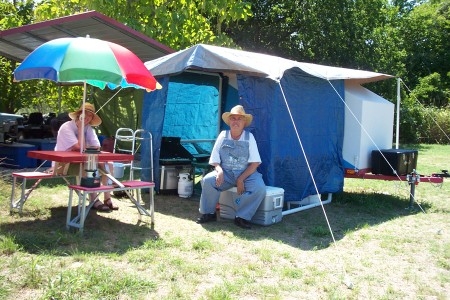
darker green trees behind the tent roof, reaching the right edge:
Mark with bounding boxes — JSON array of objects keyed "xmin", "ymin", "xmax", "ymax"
[{"xmin": 227, "ymin": 0, "xmax": 450, "ymax": 141}]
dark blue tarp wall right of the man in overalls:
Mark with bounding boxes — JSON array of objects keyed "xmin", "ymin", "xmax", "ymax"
[{"xmin": 238, "ymin": 69, "xmax": 344, "ymax": 201}]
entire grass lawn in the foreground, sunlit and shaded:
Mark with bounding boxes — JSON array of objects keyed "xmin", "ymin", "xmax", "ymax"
[{"xmin": 0, "ymin": 145, "xmax": 450, "ymax": 300}]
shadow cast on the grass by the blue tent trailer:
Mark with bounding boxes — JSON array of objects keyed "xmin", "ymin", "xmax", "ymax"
[{"xmin": 156, "ymin": 192, "xmax": 429, "ymax": 250}]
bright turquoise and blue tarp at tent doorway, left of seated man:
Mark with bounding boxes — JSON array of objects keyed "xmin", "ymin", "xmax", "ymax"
[{"xmin": 141, "ymin": 73, "xmax": 220, "ymax": 185}]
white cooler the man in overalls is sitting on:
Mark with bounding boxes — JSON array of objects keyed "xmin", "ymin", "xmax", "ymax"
[{"xmin": 219, "ymin": 186, "xmax": 284, "ymax": 226}]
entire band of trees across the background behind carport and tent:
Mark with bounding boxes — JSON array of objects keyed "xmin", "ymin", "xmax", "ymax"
[{"xmin": 0, "ymin": 0, "xmax": 450, "ymax": 144}]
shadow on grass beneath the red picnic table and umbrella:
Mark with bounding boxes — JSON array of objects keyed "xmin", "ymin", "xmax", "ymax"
[{"xmin": 1, "ymin": 206, "xmax": 159, "ymax": 256}]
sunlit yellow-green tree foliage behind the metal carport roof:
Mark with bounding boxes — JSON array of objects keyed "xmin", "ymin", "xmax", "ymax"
[{"xmin": 0, "ymin": 0, "xmax": 251, "ymax": 112}]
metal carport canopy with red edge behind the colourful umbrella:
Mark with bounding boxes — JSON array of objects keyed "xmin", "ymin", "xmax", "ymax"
[{"xmin": 0, "ymin": 11, "xmax": 174, "ymax": 62}]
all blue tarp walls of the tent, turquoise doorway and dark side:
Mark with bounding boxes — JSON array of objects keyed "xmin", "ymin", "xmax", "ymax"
[{"xmin": 143, "ymin": 69, "xmax": 344, "ymax": 201}]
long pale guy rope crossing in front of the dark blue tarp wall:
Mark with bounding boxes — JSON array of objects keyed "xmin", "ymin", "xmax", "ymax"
[{"xmin": 277, "ymin": 81, "xmax": 353, "ymax": 289}]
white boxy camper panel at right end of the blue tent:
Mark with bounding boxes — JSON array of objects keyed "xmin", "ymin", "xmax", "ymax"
[{"xmin": 342, "ymin": 80, "xmax": 394, "ymax": 170}]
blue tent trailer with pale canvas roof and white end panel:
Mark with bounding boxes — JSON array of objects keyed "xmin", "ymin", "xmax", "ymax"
[{"xmin": 142, "ymin": 45, "xmax": 394, "ymax": 213}]
